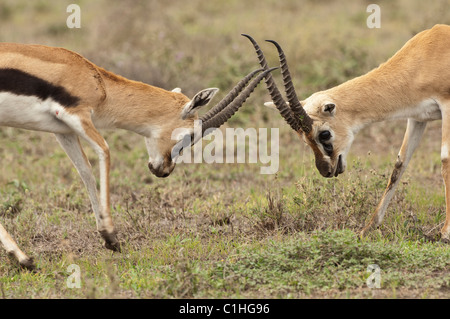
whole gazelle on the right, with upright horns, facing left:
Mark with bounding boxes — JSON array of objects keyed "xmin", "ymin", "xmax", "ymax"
[{"xmin": 244, "ymin": 25, "xmax": 450, "ymax": 243}]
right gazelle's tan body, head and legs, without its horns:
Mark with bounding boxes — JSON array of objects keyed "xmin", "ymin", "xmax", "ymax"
[{"xmin": 296, "ymin": 25, "xmax": 450, "ymax": 241}]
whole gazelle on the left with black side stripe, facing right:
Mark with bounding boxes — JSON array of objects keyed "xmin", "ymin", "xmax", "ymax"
[{"xmin": 0, "ymin": 43, "xmax": 272, "ymax": 268}]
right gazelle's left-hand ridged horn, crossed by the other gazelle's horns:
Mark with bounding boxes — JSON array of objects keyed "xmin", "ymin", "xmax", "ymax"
[{"xmin": 242, "ymin": 34, "xmax": 301, "ymax": 131}]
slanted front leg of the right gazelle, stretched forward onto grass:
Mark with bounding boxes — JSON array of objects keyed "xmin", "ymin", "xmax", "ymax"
[{"xmin": 360, "ymin": 119, "xmax": 427, "ymax": 236}]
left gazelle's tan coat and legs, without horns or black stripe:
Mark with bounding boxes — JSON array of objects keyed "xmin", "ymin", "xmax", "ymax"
[{"xmin": 0, "ymin": 43, "xmax": 217, "ymax": 268}]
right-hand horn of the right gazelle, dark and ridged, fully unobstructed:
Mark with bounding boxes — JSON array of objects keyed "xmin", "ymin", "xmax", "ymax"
[{"xmin": 266, "ymin": 40, "xmax": 313, "ymax": 134}]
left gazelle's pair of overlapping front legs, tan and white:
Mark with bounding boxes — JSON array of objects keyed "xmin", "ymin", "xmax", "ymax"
[{"xmin": 56, "ymin": 118, "xmax": 120, "ymax": 251}]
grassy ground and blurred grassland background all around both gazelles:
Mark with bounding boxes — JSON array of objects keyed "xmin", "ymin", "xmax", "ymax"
[{"xmin": 0, "ymin": 0, "xmax": 450, "ymax": 298}]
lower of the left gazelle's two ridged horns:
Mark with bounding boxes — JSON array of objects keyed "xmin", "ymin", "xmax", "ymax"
[{"xmin": 202, "ymin": 68, "xmax": 278, "ymax": 133}]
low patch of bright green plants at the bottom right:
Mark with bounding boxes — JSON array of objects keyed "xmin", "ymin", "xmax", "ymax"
[{"xmin": 216, "ymin": 230, "xmax": 450, "ymax": 294}]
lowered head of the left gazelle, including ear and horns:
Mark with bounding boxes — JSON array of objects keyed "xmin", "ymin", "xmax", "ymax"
[{"xmin": 145, "ymin": 68, "xmax": 276, "ymax": 177}]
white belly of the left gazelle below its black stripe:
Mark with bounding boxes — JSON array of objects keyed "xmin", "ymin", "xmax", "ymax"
[{"xmin": 0, "ymin": 92, "xmax": 71, "ymax": 134}]
